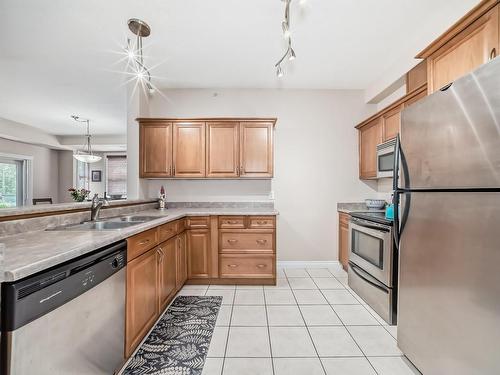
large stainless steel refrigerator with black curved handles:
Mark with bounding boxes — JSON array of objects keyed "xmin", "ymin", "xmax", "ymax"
[{"xmin": 394, "ymin": 58, "xmax": 500, "ymax": 375}]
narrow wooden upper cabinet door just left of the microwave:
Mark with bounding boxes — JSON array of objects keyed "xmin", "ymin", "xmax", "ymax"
[{"xmin": 359, "ymin": 118, "xmax": 382, "ymax": 179}]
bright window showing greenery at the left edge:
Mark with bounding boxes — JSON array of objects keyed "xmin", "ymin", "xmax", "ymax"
[{"xmin": 0, "ymin": 155, "xmax": 31, "ymax": 208}]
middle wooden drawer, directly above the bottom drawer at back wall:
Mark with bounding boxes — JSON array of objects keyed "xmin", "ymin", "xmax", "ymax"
[{"xmin": 220, "ymin": 231, "xmax": 274, "ymax": 253}]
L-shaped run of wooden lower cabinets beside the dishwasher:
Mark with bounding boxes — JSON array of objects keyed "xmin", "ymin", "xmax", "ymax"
[{"xmin": 125, "ymin": 216, "xmax": 276, "ymax": 358}]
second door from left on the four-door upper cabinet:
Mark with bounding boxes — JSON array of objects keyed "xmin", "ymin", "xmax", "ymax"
[{"xmin": 173, "ymin": 122, "xmax": 205, "ymax": 177}]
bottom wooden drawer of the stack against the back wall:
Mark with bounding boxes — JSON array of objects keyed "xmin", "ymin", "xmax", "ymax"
[{"xmin": 219, "ymin": 254, "xmax": 275, "ymax": 278}]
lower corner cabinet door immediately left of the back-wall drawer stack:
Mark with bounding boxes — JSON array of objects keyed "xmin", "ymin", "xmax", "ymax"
[{"xmin": 187, "ymin": 229, "xmax": 210, "ymax": 279}]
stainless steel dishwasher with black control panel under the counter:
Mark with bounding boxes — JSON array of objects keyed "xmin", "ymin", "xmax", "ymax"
[{"xmin": 1, "ymin": 241, "xmax": 127, "ymax": 375}]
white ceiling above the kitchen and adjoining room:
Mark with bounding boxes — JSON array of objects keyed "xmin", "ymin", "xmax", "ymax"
[{"xmin": 0, "ymin": 0, "xmax": 478, "ymax": 135}]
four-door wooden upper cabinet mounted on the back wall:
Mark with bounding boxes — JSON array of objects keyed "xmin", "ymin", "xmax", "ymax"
[{"xmin": 137, "ymin": 118, "xmax": 276, "ymax": 178}]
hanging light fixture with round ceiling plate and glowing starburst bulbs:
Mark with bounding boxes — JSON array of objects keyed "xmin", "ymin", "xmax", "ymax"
[{"xmin": 125, "ymin": 18, "xmax": 154, "ymax": 93}]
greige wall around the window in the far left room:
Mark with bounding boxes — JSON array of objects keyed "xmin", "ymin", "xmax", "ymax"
[{"xmin": 0, "ymin": 138, "xmax": 59, "ymax": 204}]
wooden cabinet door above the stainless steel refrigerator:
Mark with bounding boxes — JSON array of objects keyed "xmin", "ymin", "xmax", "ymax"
[{"xmin": 428, "ymin": 6, "xmax": 499, "ymax": 93}]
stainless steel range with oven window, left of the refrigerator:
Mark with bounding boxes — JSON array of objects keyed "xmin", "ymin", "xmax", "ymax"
[{"xmin": 348, "ymin": 212, "xmax": 398, "ymax": 325}]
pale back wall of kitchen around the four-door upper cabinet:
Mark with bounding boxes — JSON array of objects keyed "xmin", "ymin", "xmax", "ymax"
[{"xmin": 128, "ymin": 89, "xmax": 378, "ymax": 261}]
